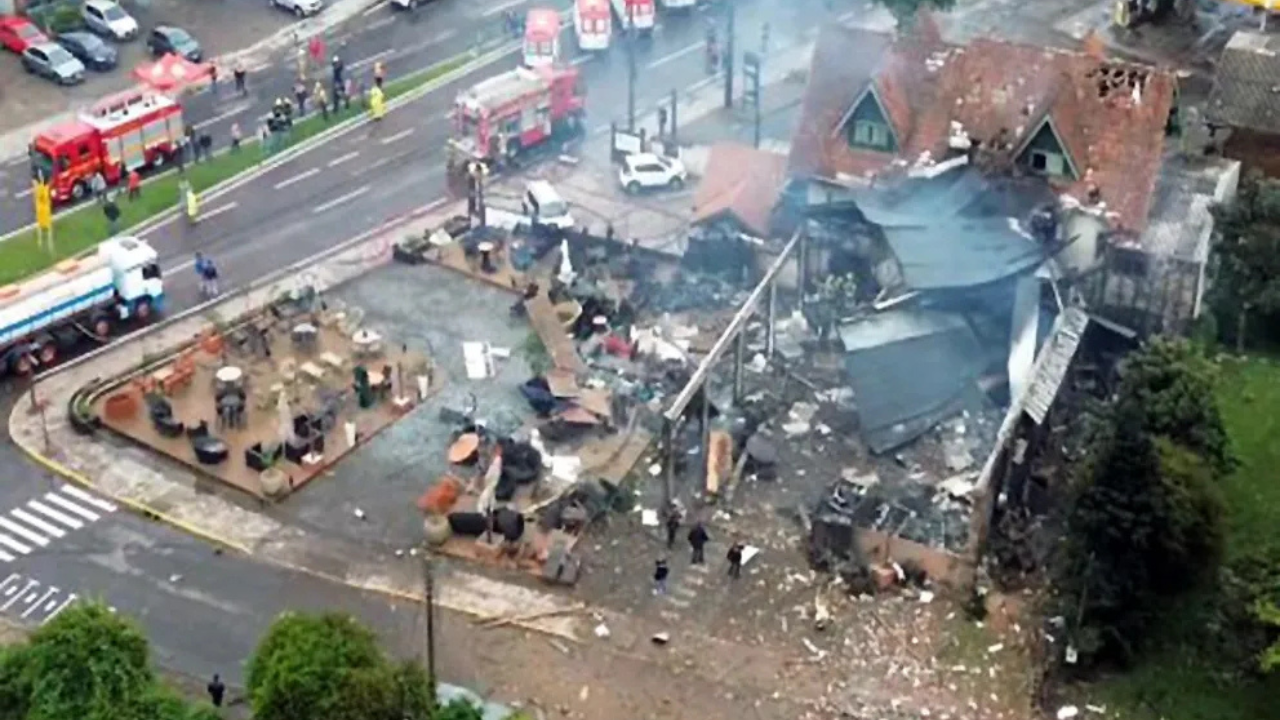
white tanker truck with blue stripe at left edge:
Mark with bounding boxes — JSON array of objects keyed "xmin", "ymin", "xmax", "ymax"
[{"xmin": 0, "ymin": 237, "xmax": 164, "ymax": 375}]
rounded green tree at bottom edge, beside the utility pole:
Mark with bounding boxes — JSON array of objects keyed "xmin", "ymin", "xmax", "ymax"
[{"xmin": 248, "ymin": 612, "xmax": 435, "ymax": 720}]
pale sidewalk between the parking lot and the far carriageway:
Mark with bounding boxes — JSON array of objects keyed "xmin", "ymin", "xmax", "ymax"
[{"xmin": 0, "ymin": 0, "xmax": 379, "ymax": 164}]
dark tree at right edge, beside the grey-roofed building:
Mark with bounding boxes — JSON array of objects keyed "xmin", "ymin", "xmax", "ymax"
[{"xmin": 1213, "ymin": 174, "xmax": 1280, "ymax": 352}]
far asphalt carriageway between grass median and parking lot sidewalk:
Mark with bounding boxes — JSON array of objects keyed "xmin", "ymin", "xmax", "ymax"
[{"xmin": 0, "ymin": 0, "xmax": 526, "ymax": 234}]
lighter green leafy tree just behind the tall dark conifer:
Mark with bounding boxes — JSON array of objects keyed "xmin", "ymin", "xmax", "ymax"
[{"xmin": 1117, "ymin": 338, "xmax": 1234, "ymax": 473}]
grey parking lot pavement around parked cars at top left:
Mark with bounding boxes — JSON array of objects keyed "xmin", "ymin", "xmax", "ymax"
[{"xmin": 0, "ymin": 0, "xmax": 294, "ymax": 129}]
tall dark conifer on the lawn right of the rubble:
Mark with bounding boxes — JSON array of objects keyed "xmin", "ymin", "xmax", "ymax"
[{"xmin": 1059, "ymin": 402, "xmax": 1224, "ymax": 661}]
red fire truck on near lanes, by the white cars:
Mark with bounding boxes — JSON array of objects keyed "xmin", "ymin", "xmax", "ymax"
[{"xmin": 449, "ymin": 67, "xmax": 584, "ymax": 168}]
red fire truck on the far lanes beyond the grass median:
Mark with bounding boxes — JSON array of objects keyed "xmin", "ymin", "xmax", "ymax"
[{"xmin": 29, "ymin": 91, "xmax": 183, "ymax": 202}]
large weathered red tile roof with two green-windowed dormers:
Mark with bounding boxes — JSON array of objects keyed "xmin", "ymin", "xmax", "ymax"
[{"xmin": 788, "ymin": 27, "xmax": 1176, "ymax": 232}]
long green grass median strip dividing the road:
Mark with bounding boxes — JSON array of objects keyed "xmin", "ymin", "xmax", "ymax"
[{"xmin": 0, "ymin": 54, "xmax": 475, "ymax": 286}]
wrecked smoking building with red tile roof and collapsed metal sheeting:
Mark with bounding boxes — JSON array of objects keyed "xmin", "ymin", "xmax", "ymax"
[{"xmin": 708, "ymin": 17, "xmax": 1239, "ymax": 580}]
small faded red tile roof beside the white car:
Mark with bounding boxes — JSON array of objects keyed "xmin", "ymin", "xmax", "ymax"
[{"xmin": 694, "ymin": 142, "xmax": 787, "ymax": 237}]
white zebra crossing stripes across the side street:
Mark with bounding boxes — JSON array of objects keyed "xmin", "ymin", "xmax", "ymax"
[{"xmin": 0, "ymin": 486, "xmax": 116, "ymax": 561}]
